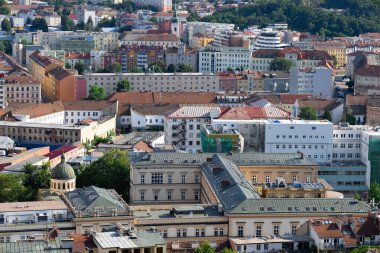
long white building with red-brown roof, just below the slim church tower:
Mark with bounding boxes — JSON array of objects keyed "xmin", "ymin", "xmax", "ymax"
[{"xmin": 119, "ymin": 33, "xmax": 181, "ymax": 49}]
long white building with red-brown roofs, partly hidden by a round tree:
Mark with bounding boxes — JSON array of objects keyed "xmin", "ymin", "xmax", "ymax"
[{"xmin": 251, "ymin": 47, "xmax": 333, "ymax": 71}]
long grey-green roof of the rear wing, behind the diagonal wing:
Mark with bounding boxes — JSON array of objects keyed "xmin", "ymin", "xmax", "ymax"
[{"xmin": 132, "ymin": 152, "xmax": 318, "ymax": 166}]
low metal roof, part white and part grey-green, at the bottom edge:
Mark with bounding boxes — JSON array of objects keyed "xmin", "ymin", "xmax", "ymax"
[{"xmin": 94, "ymin": 230, "xmax": 166, "ymax": 249}]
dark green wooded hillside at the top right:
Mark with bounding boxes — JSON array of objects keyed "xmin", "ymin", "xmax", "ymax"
[{"xmin": 201, "ymin": 0, "xmax": 380, "ymax": 37}]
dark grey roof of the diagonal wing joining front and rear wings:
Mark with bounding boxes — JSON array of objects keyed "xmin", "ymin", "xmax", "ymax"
[{"xmin": 202, "ymin": 154, "xmax": 260, "ymax": 212}]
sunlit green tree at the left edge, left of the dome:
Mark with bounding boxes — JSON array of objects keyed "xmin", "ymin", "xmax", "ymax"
[{"xmin": 0, "ymin": 174, "xmax": 27, "ymax": 203}]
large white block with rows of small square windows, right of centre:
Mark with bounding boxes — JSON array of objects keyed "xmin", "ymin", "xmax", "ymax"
[{"xmin": 265, "ymin": 120, "xmax": 333, "ymax": 163}]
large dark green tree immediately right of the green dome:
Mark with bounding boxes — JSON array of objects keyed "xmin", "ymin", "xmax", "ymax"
[{"xmin": 77, "ymin": 149, "xmax": 129, "ymax": 201}]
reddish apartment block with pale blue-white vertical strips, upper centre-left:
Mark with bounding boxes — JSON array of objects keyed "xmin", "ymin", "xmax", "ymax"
[{"xmin": 119, "ymin": 45, "xmax": 164, "ymax": 72}]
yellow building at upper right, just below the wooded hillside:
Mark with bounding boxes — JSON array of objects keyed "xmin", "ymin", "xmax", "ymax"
[{"xmin": 314, "ymin": 41, "xmax": 347, "ymax": 67}]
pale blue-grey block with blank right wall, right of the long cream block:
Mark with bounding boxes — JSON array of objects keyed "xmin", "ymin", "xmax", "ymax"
[{"xmin": 289, "ymin": 67, "xmax": 334, "ymax": 98}]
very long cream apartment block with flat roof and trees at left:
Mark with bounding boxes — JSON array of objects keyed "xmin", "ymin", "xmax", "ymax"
[{"xmin": 84, "ymin": 73, "xmax": 219, "ymax": 95}]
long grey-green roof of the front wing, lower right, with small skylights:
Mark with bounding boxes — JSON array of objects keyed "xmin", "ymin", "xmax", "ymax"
[{"xmin": 229, "ymin": 198, "xmax": 371, "ymax": 215}]
